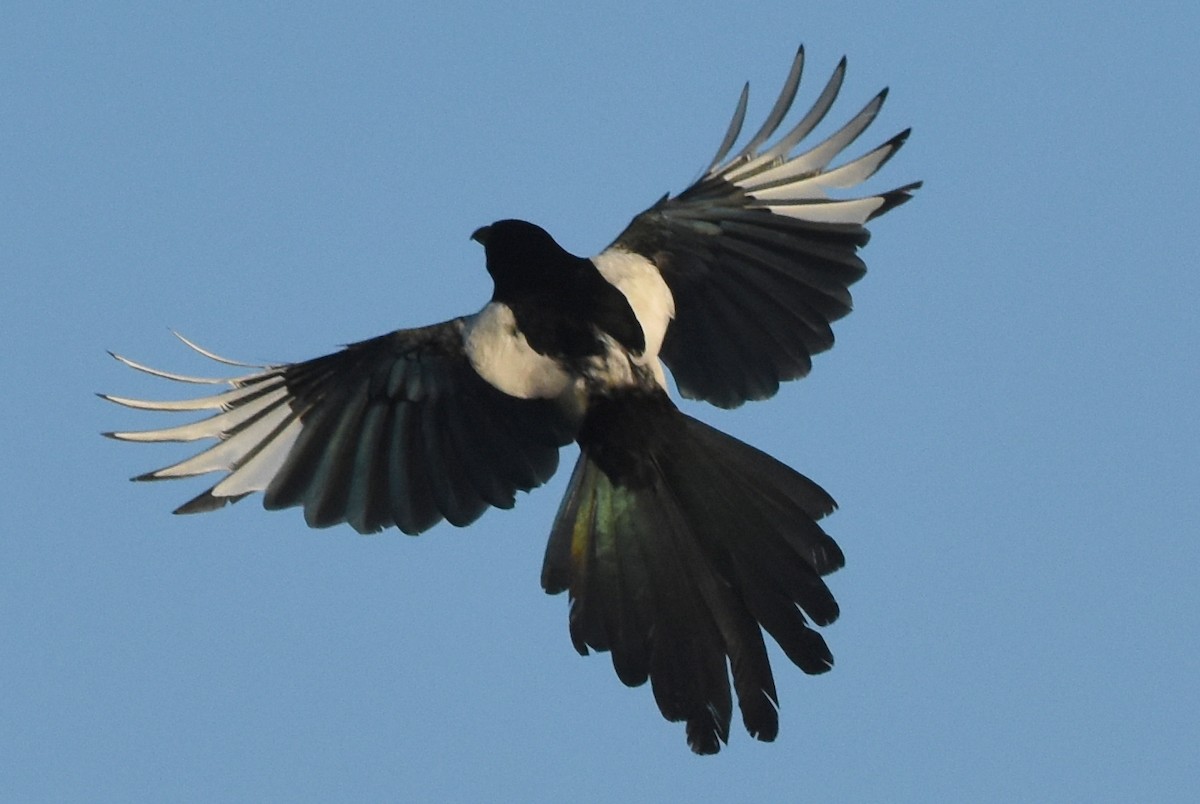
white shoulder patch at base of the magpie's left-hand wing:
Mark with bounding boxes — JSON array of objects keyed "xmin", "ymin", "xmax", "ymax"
[{"xmin": 463, "ymin": 301, "xmax": 575, "ymax": 400}]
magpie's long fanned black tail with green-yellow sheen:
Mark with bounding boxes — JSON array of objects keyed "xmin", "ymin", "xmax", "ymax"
[{"xmin": 542, "ymin": 394, "xmax": 845, "ymax": 754}]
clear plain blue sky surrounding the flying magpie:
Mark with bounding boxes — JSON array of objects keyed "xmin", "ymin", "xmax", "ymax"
[{"xmin": 0, "ymin": 0, "xmax": 1200, "ymax": 802}]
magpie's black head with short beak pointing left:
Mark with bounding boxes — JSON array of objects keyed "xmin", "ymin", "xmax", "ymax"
[{"xmin": 470, "ymin": 218, "xmax": 580, "ymax": 298}]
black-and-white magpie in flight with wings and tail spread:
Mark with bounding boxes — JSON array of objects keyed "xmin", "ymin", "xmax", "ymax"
[{"xmin": 108, "ymin": 48, "xmax": 920, "ymax": 754}]
